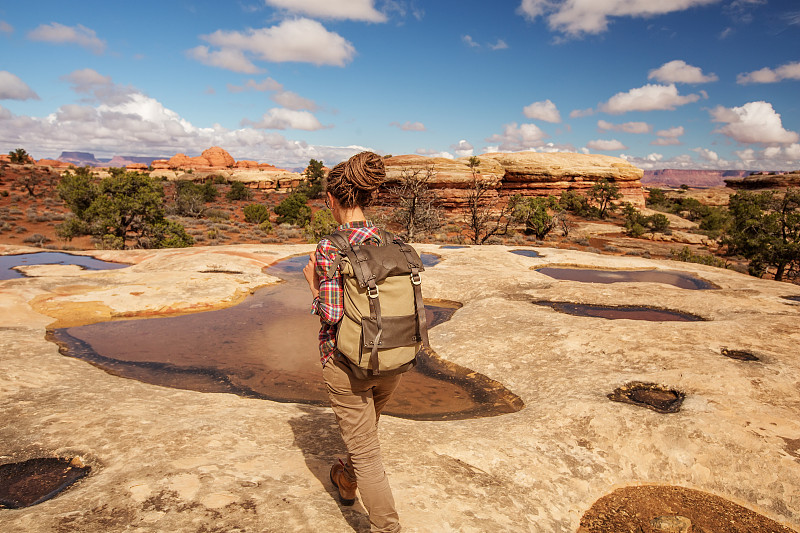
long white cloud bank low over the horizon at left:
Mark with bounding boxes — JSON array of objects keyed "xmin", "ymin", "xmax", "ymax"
[{"xmin": 0, "ymin": 82, "xmax": 360, "ymax": 168}]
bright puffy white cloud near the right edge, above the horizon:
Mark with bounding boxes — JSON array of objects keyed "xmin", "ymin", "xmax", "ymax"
[{"xmin": 710, "ymin": 101, "xmax": 800, "ymax": 144}]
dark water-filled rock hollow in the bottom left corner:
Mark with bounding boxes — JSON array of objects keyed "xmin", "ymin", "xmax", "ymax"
[{"xmin": 0, "ymin": 457, "xmax": 91, "ymax": 509}]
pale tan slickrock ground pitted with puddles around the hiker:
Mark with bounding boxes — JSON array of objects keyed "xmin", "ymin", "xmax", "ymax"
[{"xmin": 0, "ymin": 245, "xmax": 800, "ymax": 533}]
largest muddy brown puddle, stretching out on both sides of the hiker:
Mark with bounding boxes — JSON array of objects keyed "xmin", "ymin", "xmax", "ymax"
[{"xmin": 48, "ymin": 254, "xmax": 522, "ymax": 420}]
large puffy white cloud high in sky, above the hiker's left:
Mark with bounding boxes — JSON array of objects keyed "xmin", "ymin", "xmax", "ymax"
[{"xmin": 188, "ymin": 18, "xmax": 355, "ymax": 73}]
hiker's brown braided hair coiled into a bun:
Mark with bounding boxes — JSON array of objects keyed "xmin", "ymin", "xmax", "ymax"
[{"xmin": 326, "ymin": 152, "xmax": 386, "ymax": 208}]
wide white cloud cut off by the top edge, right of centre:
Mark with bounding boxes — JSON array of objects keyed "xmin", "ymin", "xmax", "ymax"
[{"xmin": 518, "ymin": 0, "xmax": 719, "ymax": 37}]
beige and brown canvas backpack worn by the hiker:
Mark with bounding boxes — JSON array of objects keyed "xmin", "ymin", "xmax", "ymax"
[{"xmin": 327, "ymin": 230, "xmax": 430, "ymax": 379}]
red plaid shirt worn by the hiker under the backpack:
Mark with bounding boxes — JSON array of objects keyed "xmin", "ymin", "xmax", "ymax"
[{"xmin": 311, "ymin": 220, "xmax": 381, "ymax": 367}]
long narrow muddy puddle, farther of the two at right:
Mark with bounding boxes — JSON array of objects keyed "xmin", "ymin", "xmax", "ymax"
[{"xmin": 535, "ymin": 267, "xmax": 719, "ymax": 291}]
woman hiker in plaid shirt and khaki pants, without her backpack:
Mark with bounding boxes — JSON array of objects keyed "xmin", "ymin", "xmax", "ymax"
[{"xmin": 303, "ymin": 152, "xmax": 400, "ymax": 532}]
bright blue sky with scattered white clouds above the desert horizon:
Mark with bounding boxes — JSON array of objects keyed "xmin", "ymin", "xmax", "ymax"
[{"xmin": 0, "ymin": 0, "xmax": 800, "ymax": 170}]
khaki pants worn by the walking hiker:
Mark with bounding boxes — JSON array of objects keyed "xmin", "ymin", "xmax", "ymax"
[{"xmin": 322, "ymin": 356, "xmax": 400, "ymax": 532}]
